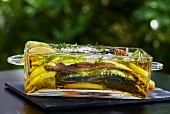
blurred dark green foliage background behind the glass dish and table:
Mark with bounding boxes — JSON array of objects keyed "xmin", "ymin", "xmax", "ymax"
[{"xmin": 0, "ymin": 0, "xmax": 170, "ymax": 73}]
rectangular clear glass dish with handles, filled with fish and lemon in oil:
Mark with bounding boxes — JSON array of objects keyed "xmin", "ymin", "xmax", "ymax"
[{"xmin": 8, "ymin": 41, "xmax": 163, "ymax": 99}]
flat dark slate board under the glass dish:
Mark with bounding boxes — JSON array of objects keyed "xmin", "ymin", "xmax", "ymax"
[{"xmin": 5, "ymin": 82, "xmax": 170, "ymax": 110}]
